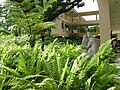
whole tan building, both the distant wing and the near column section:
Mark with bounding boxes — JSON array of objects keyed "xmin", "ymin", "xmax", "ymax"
[{"xmin": 51, "ymin": 0, "xmax": 120, "ymax": 43}]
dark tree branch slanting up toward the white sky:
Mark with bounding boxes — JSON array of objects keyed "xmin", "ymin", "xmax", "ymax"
[{"xmin": 44, "ymin": 0, "xmax": 82, "ymax": 21}]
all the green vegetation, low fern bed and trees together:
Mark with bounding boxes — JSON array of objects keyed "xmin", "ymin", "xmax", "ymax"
[{"xmin": 0, "ymin": 0, "xmax": 120, "ymax": 90}]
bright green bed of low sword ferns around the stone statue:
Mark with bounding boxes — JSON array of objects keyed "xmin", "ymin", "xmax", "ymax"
[{"xmin": 0, "ymin": 36, "xmax": 118, "ymax": 90}]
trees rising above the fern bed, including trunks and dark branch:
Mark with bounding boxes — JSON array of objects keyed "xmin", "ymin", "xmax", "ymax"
[{"xmin": 0, "ymin": 0, "xmax": 84, "ymax": 50}]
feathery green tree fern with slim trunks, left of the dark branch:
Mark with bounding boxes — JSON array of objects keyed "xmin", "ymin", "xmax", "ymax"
[{"xmin": 3, "ymin": 0, "xmax": 54, "ymax": 50}]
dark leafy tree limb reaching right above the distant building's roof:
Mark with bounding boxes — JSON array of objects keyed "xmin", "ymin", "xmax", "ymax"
[{"xmin": 44, "ymin": 0, "xmax": 84, "ymax": 21}]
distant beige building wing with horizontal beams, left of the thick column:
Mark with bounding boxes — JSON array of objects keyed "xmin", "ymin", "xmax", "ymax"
[{"xmin": 51, "ymin": 9, "xmax": 99, "ymax": 37}]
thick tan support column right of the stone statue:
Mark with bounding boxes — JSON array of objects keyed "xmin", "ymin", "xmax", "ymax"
[{"xmin": 97, "ymin": 0, "xmax": 111, "ymax": 43}]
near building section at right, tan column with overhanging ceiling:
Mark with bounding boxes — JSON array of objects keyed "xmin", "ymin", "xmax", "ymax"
[{"xmin": 97, "ymin": 0, "xmax": 120, "ymax": 43}]
